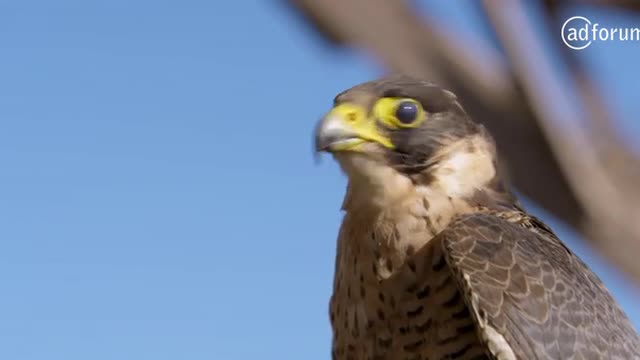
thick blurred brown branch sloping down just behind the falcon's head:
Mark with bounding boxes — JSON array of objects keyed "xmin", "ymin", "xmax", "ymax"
[{"xmin": 288, "ymin": 0, "xmax": 640, "ymax": 279}]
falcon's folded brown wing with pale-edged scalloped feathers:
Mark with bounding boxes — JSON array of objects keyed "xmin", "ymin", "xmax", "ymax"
[{"xmin": 441, "ymin": 214, "xmax": 640, "ymax": 359}]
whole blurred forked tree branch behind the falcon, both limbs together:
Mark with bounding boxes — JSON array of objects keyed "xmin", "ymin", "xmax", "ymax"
[{"xmin": 288, "ymin": 0, "xmax": 640, "ymax": 281}]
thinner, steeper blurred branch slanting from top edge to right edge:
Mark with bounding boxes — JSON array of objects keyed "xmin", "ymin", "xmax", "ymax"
[{"xmin": 482, "ymin": 0, "xmax": 640, "ymax": 279}]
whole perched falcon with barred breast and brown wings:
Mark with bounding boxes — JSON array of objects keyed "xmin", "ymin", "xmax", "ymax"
[{"xmin": 315, "ymin": 76, "xmax": 640, "ymax": 360}]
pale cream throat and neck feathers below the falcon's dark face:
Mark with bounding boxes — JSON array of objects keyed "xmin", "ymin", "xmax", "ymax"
[{"xmin": 338, "ymin": 136, "xmax": 517, "ymax": 277}]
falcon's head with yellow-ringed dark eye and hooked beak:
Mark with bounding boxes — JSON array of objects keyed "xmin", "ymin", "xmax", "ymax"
[{"xmin": 315, "ymin": 76, "xmax": 502, "ymax": 211}]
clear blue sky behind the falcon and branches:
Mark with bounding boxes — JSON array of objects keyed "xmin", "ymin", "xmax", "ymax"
[{"xmin": 0, "ymin": 0, "xmax": 640, "ymax": 360}]
